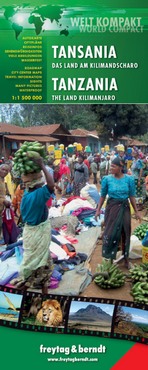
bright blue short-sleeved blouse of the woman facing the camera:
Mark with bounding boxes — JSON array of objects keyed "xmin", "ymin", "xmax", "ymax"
[{"xmin": 101, "ymin": 174, "xmax": 135, "ymax": 199}]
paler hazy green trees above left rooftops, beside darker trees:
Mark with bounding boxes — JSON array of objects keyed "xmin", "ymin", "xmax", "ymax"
[{"xmin": 0, "ymin": 104, "xmax": 97, "ymax": 130}]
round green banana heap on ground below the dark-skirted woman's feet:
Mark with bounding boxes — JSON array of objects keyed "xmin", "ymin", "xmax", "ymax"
[{"xmin": 94, "ymin": 260, "xmax": 125, "ymax": 289}]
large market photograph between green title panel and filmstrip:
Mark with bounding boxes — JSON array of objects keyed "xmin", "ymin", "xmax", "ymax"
[{"xmin": 0, "ymin": 104, "xmax": 148, "ymax": 304}]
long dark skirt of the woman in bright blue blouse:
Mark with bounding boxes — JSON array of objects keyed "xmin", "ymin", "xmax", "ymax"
[{"xmin": 102, "ymin": 199, "xmax": 131, "ymax": 260}]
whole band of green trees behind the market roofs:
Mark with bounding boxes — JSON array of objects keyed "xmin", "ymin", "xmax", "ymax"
[{"xmin": 0, "ymin": 104, "xmax": 148, "ymax": 140}]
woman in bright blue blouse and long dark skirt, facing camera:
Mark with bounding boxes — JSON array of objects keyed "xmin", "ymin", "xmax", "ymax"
[{"xmin": 95, "ymin": 157, "xmax": 140, "ymax": 267}]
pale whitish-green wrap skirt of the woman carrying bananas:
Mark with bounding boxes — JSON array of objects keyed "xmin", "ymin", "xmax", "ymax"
[{"xmin": 20, "ymin": 220, "xmax": 52, "ymax": 288}]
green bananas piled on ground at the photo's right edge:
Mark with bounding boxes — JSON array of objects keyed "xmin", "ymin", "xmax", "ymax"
[{"xmin": 129, "ymin": 264, "xmax": 148, "ymax": 304}]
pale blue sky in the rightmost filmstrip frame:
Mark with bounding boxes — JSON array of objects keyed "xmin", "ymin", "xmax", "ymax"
[{"xmin": 122, "ymin": 306, "xmax": 148, "ymax": 325}]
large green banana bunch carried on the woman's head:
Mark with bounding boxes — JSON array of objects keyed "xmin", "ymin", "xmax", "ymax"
[{"xmin": 13, "ymin": 141, "xmax": 47, "ymax": 176}]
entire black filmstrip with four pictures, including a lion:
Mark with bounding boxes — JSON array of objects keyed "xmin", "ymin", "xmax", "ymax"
[{"xmin": 0, "ymin": 286, "xmax": 148, "ymax": 344}]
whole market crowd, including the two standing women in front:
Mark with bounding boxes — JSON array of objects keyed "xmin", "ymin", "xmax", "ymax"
[{"xmin": 0, "ymin": 147, "xmax": 148, "ymax": 292}]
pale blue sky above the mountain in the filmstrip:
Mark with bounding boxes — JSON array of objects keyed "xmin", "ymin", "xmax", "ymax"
[{"xmin": 70, "ymin": 301, "xmax": 114, "ymax": 316}]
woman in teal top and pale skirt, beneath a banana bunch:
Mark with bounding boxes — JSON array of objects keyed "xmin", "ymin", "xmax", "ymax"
[{"xmin": 11, "ymin": 158, "xmax": 54, "ymax": 294}]
